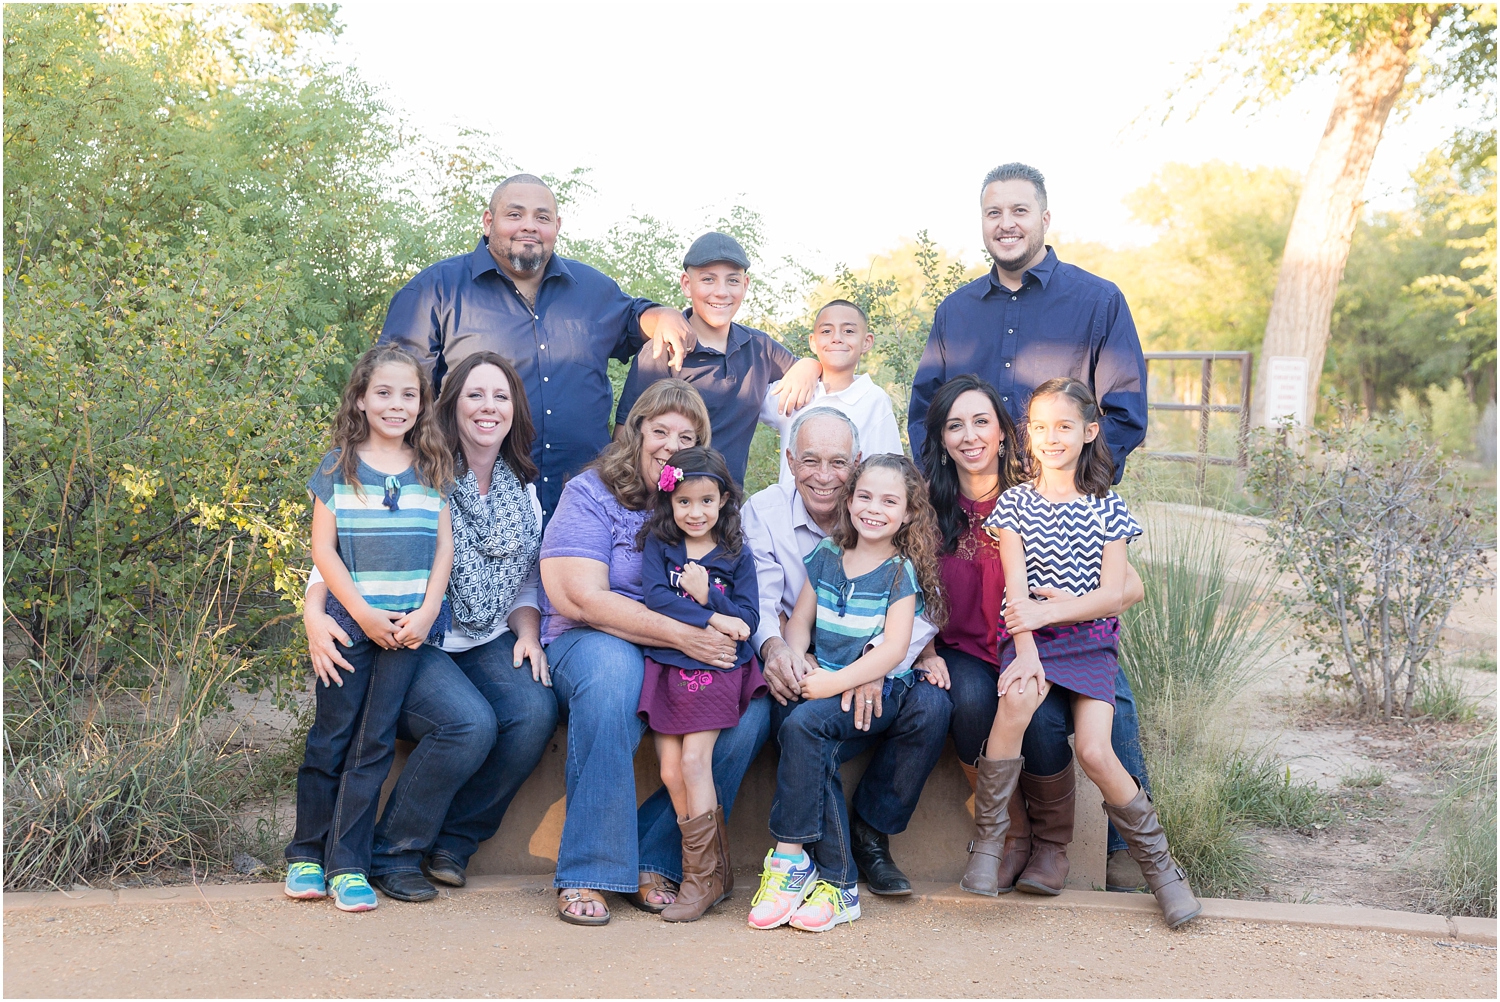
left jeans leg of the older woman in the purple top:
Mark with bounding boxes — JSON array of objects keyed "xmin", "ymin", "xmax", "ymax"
[{"xmin": 548, "ymin": 627, "xmax": 645, "ymax": 894}]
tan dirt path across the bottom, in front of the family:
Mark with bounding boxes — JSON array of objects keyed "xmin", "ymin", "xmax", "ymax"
[{"xmin": 5, "ymin": 888, "xmax": 1496, "ymax": 998}]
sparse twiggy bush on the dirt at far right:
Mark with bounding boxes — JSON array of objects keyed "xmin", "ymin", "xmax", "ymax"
[{"xmin": 1250, "ymin": 411, "xmax": 1494, "ymax": 717}]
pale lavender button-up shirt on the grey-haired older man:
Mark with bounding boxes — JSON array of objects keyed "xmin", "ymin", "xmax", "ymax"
[{"xmin": 743, "ymin": 480, "xmax": 938, "ymax": 675}]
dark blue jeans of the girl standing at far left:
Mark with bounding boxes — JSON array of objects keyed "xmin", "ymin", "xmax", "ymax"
[{"xmin": 287, "ymin": 641, "xmax": 419, "ymax": 878}]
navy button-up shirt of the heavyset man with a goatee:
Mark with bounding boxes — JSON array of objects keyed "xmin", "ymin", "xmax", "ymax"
[{"xmin": 380, "ymin": 240, "xmax": 665, "ymax": 519}]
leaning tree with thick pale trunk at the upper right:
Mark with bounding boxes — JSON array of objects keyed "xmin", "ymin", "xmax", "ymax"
[{"xmin": 1190, "ymin": 3, "xmax": 1496, "ymax": 417}]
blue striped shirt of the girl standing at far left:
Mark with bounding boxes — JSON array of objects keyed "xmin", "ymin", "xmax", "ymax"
[{"xmin": 308, "ymin": 449, "xmax": 447, "ymax": 612}]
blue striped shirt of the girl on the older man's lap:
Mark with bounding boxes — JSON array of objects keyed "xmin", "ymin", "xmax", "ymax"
[{"xmin": 803, "ymin": 539, "xmax": 924, "ymax": 678}]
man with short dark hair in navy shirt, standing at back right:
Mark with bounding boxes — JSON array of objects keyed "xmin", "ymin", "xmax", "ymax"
[{"xmin": 908, "ymin": 164, "xmax": 1149, "ymax": 894}]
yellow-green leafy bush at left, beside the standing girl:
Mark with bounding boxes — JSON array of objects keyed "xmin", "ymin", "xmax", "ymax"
[{"xmin": 5, "ymin": 234, "xmax": 338, "ymax": 681}]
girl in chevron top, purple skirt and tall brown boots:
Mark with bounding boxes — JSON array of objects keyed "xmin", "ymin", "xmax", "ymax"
[{"xmin": 962, "ymin": 378, "xmax": 1202, "ymax": 927}]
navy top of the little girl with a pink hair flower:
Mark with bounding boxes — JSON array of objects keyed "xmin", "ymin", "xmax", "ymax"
[{"xmin": 641, "ymin": 536, "xmax": 761, "ymax": 672}]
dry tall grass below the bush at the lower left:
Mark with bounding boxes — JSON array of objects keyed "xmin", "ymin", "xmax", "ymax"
[{"xmin": 3, "ymin": 576, "xmax": 276, "ymax": 890}]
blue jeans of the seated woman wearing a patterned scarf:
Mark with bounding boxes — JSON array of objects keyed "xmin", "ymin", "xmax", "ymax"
[{"xmin": 371, "ymin": 633, "xmax": 558, "ymax": 873}]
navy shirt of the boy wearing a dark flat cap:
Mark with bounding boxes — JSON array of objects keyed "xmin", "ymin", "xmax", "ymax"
[{"xmin": 615, "ymin": 309, "xmax": 797, "ymax": 485}]
